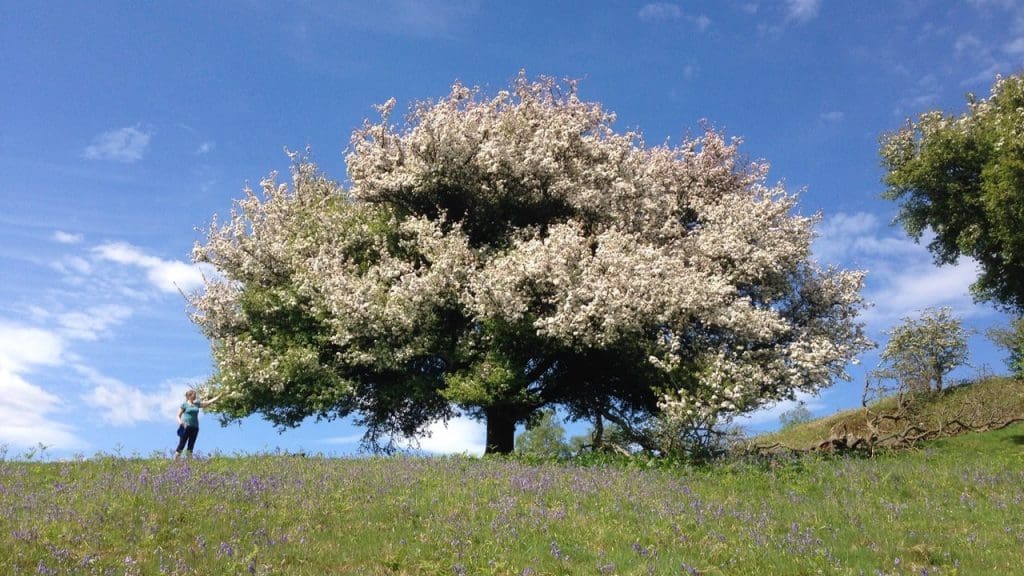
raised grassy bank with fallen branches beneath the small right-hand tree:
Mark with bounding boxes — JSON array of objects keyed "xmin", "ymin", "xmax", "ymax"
[{"xmin": 753, "ymin": 377, "xmax": 1024, "ymax": 450}]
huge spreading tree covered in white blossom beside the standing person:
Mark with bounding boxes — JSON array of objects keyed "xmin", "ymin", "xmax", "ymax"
[{"xmin": 191, "ymin": 76, "xmax": 868, "ymax": 452}]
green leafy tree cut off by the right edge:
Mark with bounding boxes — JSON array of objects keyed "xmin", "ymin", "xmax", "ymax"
[{"xmin": 881, "ymin": 75, "xmax": 1024, "ymax": 312}]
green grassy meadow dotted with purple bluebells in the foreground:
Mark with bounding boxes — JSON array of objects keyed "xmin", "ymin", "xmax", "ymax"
[{"xmin": 0, "ymin": 424, "xmax": 1024, "ymax": 576}]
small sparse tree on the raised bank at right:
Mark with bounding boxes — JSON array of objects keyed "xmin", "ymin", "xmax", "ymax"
[{"xmin": 871, "ymin": 307, "xmax": 972, "ymax": 393}]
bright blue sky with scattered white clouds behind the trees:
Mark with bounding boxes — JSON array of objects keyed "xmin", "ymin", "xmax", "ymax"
[{"xmin": 0, "ymin": 0, "xmax": 1024, "ymax": 457}]
